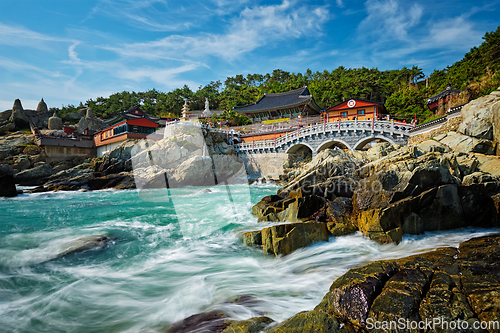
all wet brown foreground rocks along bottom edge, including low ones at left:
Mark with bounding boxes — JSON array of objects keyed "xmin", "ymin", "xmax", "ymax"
[{"xmin": 167, "ymin": 234, "xmax": 500, "ymax": 333}]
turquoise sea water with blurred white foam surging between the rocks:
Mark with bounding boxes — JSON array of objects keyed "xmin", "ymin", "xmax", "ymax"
[{"xmin": 0, "ymin": 185, "xmax": 498, "ymax": 332}]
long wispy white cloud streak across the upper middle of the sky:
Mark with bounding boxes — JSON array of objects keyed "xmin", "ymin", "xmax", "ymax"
[{"xmin": 107, "ymin": 0, "xmax": 329, "ymax": 61}]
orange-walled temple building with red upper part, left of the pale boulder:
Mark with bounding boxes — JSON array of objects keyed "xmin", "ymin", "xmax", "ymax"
[{"xmin": 94, "ymin": 106, "xmax": 163, "ymax": 156}]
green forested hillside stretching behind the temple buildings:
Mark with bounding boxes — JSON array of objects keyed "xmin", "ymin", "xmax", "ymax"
[{"xmin": 59, "ymin": 27, "xmax": 500, "ymax": 120}]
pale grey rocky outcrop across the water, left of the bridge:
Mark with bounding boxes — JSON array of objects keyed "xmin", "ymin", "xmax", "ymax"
[{"xmin": 30, "ymin": 122, "xmax": 244, "ymax": 191}]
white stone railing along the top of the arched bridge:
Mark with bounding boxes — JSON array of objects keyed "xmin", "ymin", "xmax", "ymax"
[{"xmin": 235, "ymin": 120, "xmax": 413, "ymax": 151}]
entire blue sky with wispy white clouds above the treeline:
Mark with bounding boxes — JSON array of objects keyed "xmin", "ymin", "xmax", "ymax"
[{"xmin": 0, "ymin": 0, "xmax": 500, "ymax": 110}]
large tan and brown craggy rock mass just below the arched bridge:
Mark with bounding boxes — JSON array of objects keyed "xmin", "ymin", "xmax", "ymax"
[{"xmin": 245, "ymin": 133, "xmax": 500, "ymax": 254}]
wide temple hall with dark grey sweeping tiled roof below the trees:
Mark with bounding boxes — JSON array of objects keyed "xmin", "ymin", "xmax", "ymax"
[{"xmin": 233, "ymin": 86, "xmax": 322, "ymax": 121}]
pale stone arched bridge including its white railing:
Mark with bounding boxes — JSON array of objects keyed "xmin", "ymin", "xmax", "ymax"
[{"xmin": 235, "ymin": 120, "xmax": 413, "ymax": 156}]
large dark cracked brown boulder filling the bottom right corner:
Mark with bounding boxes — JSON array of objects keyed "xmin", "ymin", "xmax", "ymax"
[{"xmin": 315, "ymin": 235, "xmax": 500, "ymax": 332}]
